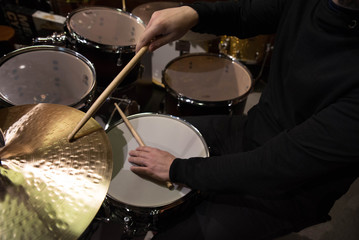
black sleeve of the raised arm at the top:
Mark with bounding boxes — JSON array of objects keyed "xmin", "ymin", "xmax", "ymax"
[{"xmin": 189, "ymin": 0, "xmax": 287, "ymax": 38}]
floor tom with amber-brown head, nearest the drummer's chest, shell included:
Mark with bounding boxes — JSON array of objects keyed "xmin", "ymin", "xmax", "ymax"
[{"xmin": 162, "ymin": 53, "xmax": 252, "ymax": 116}]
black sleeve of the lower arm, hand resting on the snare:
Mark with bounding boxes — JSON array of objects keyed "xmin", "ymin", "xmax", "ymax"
[{"xmin": 170, "ymin": 88, "xmax": 359, "ymax": 194}]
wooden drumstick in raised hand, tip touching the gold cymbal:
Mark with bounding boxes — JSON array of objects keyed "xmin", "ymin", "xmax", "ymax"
[{"xmin": 67, "ymin": 46, "xmax": 148, "ymax": 141}]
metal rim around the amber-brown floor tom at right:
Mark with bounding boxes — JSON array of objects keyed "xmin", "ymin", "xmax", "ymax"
[{"xmin": 162, "ymin": 52, "xmax": 254, "ymax": 107}]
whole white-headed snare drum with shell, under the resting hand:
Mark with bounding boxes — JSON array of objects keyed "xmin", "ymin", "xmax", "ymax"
[{"xmin": 105, "ymin": 113, "xmax": 209, "ymax": 234}]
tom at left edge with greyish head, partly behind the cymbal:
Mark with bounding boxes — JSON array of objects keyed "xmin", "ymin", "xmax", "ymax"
[{"xmin": 0, "ymin": 46, "xmax": 96, "ymax": 109}]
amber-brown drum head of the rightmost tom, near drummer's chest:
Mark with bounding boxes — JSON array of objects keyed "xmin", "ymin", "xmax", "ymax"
[{"xmin": 163, "ymin": 53, "xmax": 252, "ymax": 102}]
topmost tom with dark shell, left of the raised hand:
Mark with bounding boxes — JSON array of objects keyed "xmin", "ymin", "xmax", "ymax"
[{"xmin": 64, "ymin": 7, "xmax": 145, "ymax": 89}]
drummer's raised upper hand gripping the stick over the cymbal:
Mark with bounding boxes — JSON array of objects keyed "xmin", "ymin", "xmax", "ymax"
[{"xmin": 136, "ymin": 6, "xmax": 198, "ymax": 52}]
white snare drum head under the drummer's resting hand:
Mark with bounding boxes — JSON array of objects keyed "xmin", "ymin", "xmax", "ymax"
[{"xmin": 107, "ymin": 114, "xmax": 208, "ymax": 208}]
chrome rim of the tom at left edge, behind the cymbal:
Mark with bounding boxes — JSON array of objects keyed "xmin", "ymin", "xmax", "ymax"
[{"xmin": 0, "ymin": 45, "xmax": 96, "ymax": 108}]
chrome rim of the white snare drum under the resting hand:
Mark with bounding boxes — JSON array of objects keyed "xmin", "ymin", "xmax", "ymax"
[{"xmin": 105, "ymin": 112, "xmax": 210, "ymax": 213}]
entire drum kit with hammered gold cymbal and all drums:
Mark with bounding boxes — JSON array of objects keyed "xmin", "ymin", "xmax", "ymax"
[{"xmin": 0, "ymin": 2, "xmax": 272, "ymax": 239}]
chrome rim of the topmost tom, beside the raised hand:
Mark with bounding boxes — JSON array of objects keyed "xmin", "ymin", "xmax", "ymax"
[{"xmin": 64, "ymin": 6, "xmax": 146, "ymax": 53}]
